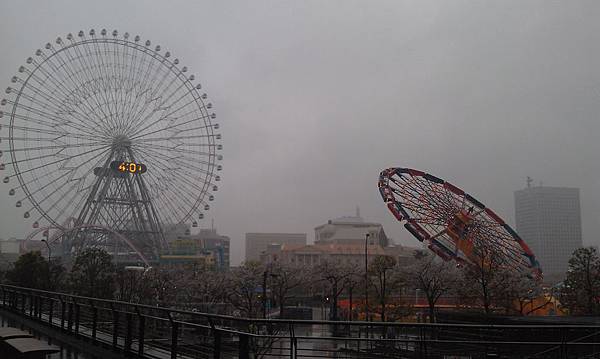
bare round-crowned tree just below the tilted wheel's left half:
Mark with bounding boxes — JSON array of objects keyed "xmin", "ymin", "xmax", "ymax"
[{"xmin": 408, "ymin": 254, "xmax": 457, "ymax": 323}]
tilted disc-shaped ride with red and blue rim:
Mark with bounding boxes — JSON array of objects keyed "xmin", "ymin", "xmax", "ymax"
[{"xmin": 378, "ymin": 168, "xmax": 541, "ymax": 278}]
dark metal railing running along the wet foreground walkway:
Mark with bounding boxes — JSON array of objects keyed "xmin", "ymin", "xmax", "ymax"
[{"xmin": 0, "ymin": 285, "xmax": 600, "ymax": 359}]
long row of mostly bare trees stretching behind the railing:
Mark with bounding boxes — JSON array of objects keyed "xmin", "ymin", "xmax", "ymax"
[{"xmin": 3, "ymin": 247, "xmax": 600, "ymax": 322}]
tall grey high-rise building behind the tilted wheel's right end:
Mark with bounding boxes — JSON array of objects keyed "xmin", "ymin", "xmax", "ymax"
[{"xmin": 515, "ymin": 181, "xmax": 582, "ymax": 280}]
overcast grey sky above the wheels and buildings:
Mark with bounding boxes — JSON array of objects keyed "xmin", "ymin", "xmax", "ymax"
[{"xmin": 0, "ymin": 0, "xmax": 600, "ymax": 263}]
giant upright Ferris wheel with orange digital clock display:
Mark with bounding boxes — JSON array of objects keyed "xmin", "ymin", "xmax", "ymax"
[{"xmin": 0, "ymin": 30, "xmax": 222, "ymax": 262}]
